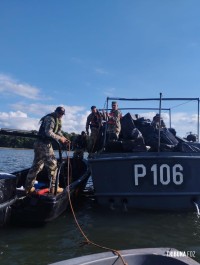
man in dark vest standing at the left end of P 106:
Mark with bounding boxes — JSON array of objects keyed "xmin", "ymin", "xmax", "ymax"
[{"xmin": 85, "ymin": 106, "xmax": 102, "ymax": 153}]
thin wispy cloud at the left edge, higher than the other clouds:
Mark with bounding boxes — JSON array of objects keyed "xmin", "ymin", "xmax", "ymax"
[{"xmin": 0, "ymin": 74, "xmax": 41, "ymax": 99}]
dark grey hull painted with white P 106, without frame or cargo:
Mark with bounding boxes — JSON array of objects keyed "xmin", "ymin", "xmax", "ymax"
[{"xmin": 89, "ymin": 152, "xmax": 200, "ymax": 210}]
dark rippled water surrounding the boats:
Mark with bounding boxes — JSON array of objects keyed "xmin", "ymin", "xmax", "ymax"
[{"xmin": 0, "ymin": 148, "xmax": 200, "ymax": 265}]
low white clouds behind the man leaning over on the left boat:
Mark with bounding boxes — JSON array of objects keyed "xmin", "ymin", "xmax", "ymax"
[{"xmin": 0, "ymin": 103, "xmax": 88, "ymax": 133}]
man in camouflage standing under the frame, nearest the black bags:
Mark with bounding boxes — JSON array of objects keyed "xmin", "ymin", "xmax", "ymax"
[{"xmin": 106, "ymin": 101, "xmax": 122, "ymax": 140}]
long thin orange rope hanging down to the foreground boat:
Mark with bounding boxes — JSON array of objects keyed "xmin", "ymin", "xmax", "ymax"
[{"xmin": 67, "ymin": 144, "xmax": 128, "ymax": 265}]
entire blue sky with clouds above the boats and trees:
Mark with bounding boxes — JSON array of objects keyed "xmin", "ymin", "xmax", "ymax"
[{"xmin": 0, "ymin": 0, "xmax": 200, "ymax": 135}]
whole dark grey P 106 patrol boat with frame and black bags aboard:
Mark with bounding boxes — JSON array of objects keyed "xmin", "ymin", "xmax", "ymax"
[{"xmin": 88, "ymin": 94, "xmax": 200, "ymax": 210}]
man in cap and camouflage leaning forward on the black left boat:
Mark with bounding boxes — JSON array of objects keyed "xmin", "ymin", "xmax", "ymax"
[{"xmin": 25, "ymin": 107, "xmax": 69, "ymax": 194}]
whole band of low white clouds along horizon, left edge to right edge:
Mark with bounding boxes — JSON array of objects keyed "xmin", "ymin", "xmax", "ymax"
[{"xmin": 0, "ymin": 103, "xmax": 197, "ymax": 137}]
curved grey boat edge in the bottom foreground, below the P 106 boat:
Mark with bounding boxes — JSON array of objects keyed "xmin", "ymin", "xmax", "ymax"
[{"xmin": 49, "ymin": 248, "xmax": 200, "ymax": 265}]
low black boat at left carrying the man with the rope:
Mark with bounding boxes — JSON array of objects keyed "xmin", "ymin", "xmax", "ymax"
[{"xmin": 0, "ymin": 129, "xmax": 90, "ymax": 226}]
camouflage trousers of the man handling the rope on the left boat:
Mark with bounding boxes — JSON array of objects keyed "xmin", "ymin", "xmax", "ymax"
[{"xmin": 25, "ymin": 141, "xmax": 57, "ymax": 192}]
